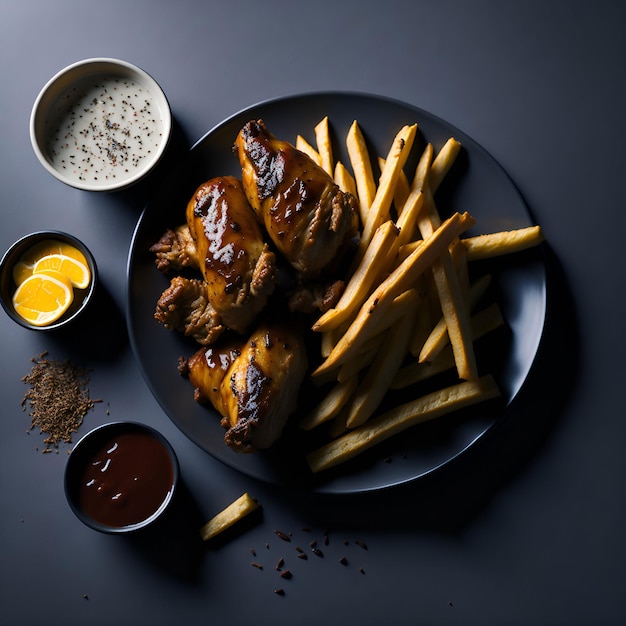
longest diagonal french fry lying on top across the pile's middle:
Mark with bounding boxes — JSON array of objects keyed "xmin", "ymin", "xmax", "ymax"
[{"xmin": 312, "ymin": 213, "xmax": 474, "ymax": 377}]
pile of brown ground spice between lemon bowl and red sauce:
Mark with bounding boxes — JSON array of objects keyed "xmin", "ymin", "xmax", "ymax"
[{"xmin": 22, "ymin": 352, "xmax": 100, "ymax": 452}]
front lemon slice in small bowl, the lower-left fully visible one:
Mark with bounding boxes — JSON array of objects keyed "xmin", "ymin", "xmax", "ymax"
[{"xmin": 13, "ymin": 270, "xmax": 74, "ymax": 326}]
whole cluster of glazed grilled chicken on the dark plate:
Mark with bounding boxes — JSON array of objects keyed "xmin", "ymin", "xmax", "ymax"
[{"xmin": 151, "ymin": 120, "xmax": 358, "ymax": 452}]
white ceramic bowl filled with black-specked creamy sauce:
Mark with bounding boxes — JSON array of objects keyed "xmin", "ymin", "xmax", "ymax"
[{"xmin": 30, "ymin": 58, "xmax": 172, "ymax": 191}]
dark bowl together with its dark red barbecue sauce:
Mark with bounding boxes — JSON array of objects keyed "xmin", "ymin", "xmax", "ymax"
[{"xmin": 65, "ymin": 422, "xmax": 180, "ymax": 534}]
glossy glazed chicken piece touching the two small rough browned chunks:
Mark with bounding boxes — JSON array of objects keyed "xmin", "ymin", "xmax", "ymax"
[{"xmin": 187, "ymin": 176, "xmax": 276, "ymax": 333}]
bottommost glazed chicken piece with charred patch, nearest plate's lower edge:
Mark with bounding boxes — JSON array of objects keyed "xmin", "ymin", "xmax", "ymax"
[{"xmin": 180, "ymin": 325, "xmax": 307, "ymax": 453}]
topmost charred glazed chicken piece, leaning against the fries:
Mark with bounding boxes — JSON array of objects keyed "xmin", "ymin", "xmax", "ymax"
[{"xmin": 234, "ymin": 120, "xmax": 358, "ymax": 277}]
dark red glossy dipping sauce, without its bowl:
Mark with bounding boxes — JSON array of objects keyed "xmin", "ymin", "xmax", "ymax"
[{"xmin": 77, "ymin": 431, "xmax": 174, "ymax": 528}]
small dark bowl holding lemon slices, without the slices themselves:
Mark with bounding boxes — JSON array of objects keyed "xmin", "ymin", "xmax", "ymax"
[{"xmin": 0, "ymin": 230, "xmax": 98, "ymax": 331}]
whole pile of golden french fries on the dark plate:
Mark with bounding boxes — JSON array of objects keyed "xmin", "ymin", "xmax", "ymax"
[{"xmin": 296, "ymin": 117, "xmax": 543, "ymax": 472}]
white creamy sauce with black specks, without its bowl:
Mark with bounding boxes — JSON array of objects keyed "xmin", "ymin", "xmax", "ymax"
[{"xmin": 48, "ymin": 77, "xmax": 163, "ymax": 184}]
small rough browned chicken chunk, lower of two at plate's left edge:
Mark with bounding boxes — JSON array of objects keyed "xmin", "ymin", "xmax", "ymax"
[{"xmin": 154, "ymin": 276, "xmax": 225, "ymax": 346}]
